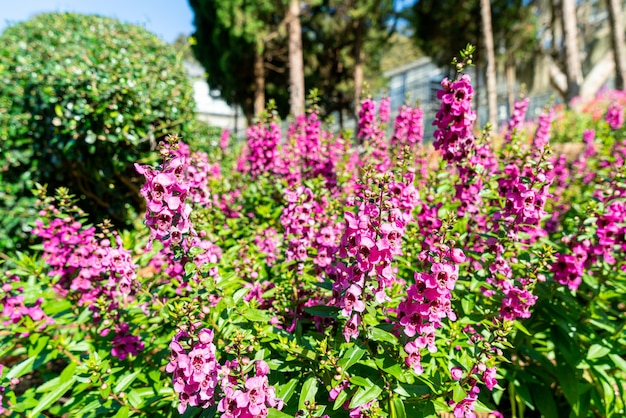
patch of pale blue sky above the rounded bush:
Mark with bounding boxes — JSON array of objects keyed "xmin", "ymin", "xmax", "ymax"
[{"xmin": 0, "ymin": 0, "xmax": 194, "ymax": 43}]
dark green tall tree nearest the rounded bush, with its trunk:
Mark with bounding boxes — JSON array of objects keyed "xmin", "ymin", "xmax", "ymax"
[{"xmin": 189, "ymin": 0, "xmax": 288, "ymax": 122}]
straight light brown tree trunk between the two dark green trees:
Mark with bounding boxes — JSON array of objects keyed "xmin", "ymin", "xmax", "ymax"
[{"xmin": 288, "ymin": 0, "xmax": 304, "ymax": 116}]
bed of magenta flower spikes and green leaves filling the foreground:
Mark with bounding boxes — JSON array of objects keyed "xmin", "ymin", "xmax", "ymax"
[{"xmin": 0, "ymin": 56, "xmax": 626, "ymax": 418}]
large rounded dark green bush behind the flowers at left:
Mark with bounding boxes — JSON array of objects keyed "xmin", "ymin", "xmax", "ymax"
[{"xmin": 0, "ymin": 13, "xmax": 194, "ymax": 250}]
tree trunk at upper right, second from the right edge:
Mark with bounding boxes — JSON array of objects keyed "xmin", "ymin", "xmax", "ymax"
[{"xmin": 561, "ymin": 0, "xmax": 583, "ymax": 102}]
